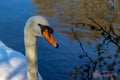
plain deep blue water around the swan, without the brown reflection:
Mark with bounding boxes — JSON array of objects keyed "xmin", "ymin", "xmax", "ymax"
[{"xmin": 0, "ymin": 0, "xmax": 86, "ymax": 80}]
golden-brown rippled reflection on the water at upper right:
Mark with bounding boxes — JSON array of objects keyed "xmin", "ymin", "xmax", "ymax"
[{"xmin": 32, "ymin": 0, "xmax": 120, "ymax": 43}]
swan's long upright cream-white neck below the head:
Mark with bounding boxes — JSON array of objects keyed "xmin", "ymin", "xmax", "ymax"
[{"xmin": 24, "ymin": 28, "xmax": 38, "ymax": 80}]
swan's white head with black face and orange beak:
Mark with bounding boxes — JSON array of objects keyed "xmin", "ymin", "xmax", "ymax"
[{"xmin": 26, "ymin": 16, "xmax": 58, "ymax": 48}]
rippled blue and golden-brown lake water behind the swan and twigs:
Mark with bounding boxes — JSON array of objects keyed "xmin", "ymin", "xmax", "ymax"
[{"xmin": 0, "ymin": 0, "xmax": 120, "ymax": 80}]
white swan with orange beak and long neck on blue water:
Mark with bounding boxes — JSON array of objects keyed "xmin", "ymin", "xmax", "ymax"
[{"xmin": 0, "ymin": 16, "xmax": 58, "ymax": 80}]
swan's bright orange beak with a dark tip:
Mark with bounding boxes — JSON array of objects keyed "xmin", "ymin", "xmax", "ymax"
[{"xmin": 42, "ymin": 29, "xmax": 58, "ymax": 48}]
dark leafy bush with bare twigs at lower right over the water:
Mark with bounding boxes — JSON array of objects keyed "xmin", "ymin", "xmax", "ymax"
[{"xmin": 70, "ymin": 18, "xmax": 120, "ymax": 80}]
